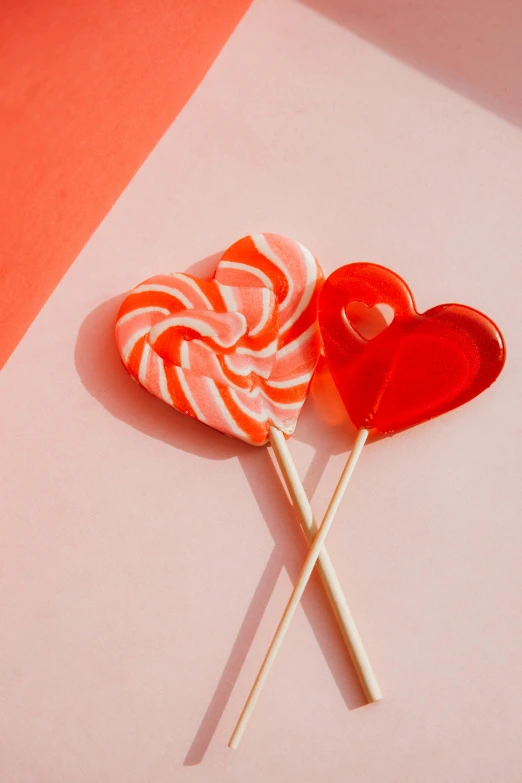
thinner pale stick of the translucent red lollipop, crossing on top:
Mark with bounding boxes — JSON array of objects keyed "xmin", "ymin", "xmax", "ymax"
[{"xmin": 228, "ymin": 429, "xmax": 368, "ymax": 748}]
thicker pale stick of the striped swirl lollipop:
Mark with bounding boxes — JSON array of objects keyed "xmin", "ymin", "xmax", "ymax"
[{"xmin": 270, "ymin": 427, "xmax": 382, "ymax": 701}]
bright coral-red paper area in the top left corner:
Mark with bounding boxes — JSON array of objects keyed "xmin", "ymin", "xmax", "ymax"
[{"xmin": 0, "ymin": 0, "xmax": 251, "ymax": 367}]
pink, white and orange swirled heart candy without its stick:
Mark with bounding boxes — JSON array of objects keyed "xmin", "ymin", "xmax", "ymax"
[{"xmin": 116, "ymin": 234, "xmax": 323, "ymax": 445}]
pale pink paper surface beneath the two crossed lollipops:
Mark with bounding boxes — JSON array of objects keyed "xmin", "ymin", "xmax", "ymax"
[{"xmin": 0, "ymin": 0, "xmax": 522, "ymax": 783}]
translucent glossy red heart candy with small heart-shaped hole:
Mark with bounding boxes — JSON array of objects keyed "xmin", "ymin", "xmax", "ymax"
[{"xmin": 318, "ymin": 263, "xmax": 505, "ymax": 434}]
